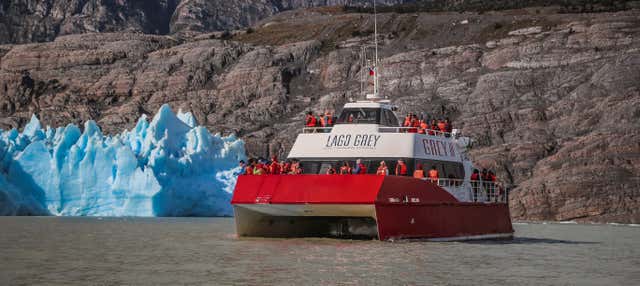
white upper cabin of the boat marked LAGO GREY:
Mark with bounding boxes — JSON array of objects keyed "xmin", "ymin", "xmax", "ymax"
[{"xmin": 288, "ymin": 100, "xmax": 502, "ymax": 201}]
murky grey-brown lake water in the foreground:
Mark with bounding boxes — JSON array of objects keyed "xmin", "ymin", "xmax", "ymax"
[{"xmin": 0, "ymin": 217, "xmax": 640, "ymax": 285}]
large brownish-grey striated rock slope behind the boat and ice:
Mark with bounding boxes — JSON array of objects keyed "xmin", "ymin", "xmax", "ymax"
[{"xmin": 0, "ymin": 6, "xmax": 640, "ymax": 223}]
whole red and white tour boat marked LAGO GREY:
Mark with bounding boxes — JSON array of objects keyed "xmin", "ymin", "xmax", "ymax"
[{"xmin": 231, "ymin": 1, "xmax": 513, "ymax": 240}]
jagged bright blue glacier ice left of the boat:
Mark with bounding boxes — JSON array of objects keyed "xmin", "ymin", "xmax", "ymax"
[{"xmin": 0, "ymin": 105, "xmax": 246, "ymax": 216}]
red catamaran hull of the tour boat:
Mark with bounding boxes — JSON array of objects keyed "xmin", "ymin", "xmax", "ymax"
[{"xmin": 231, "ymin": 175, "xmax": 513, "ymax": 240}]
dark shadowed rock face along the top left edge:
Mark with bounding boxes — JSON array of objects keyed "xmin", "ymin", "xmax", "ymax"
[{"xmin": 0, "ymin": 0, "xmax": 413, "ymax": 44}]
